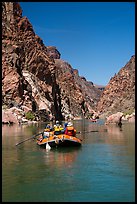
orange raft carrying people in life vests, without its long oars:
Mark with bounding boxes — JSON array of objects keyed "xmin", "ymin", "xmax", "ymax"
[{"xmin": 37, "ymin": 121, "xmax": 81, "ymax": 149}]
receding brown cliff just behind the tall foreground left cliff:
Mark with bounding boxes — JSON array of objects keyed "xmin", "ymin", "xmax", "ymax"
[{"xmin": 55, "ymin": 59, "xmax": 101, "ymax": 117}]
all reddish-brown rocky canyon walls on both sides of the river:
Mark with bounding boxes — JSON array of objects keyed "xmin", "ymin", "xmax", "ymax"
[{"xmin": 2, "ymin": 2, "xmax": 135, "ymax": 121}]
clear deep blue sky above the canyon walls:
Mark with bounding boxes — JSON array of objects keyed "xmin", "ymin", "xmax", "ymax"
[{"xmin": 20, "ymin": 2, "xmax": 135, "ymax": 85}]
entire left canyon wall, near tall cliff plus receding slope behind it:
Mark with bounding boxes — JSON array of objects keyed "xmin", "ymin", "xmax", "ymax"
[{"xmin": 2, "ymin": 2, "xmax": 101, "ymax": 119}]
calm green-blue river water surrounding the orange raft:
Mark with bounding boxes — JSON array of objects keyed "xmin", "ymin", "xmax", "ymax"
[{"xmin": 2, "ymin": 120, "xmax": 135, "ymax": 202}]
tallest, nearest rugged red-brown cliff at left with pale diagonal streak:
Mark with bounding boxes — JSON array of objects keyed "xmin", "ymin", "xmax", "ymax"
[{"xmin": 2, "ymin": 2, "xmax": 64, "ymax": 120}]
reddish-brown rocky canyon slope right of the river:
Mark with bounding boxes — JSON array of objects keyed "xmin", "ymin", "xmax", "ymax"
[{"xmin": 96, "ymin": 55, "xmax": 135, "ymax": 116}]
